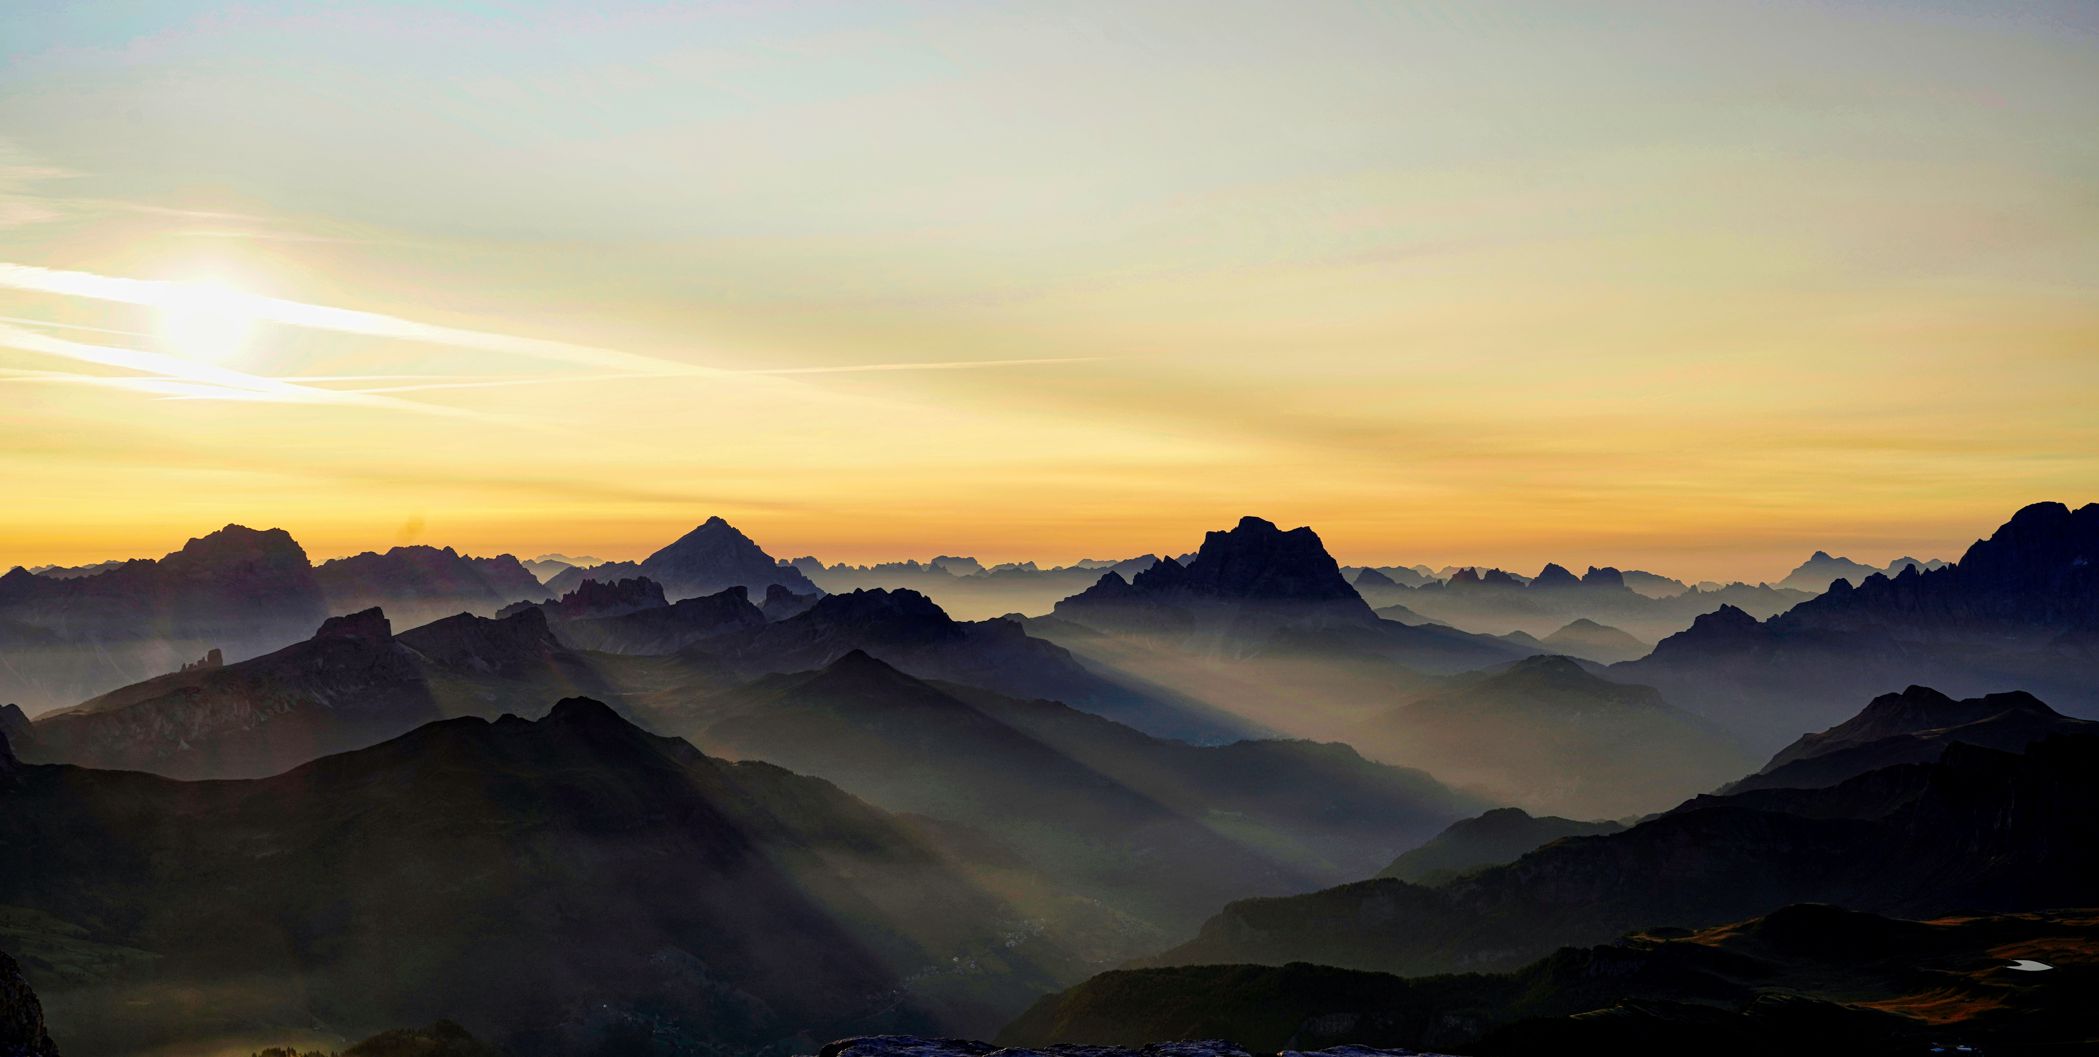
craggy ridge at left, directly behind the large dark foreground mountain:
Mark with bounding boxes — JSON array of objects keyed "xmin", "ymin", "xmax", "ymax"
[{"xmin": 21, "ymin": 610, "xmax": 602, "ymax": 778}]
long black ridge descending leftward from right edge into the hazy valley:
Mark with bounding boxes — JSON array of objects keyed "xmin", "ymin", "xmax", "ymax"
[{"xmin": 1152, "ymin": 736, "xmax": 2099, "ymax": 973}]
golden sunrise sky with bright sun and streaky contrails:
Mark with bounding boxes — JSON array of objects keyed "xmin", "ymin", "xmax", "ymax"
[{"xmin": 0, "ymin": 0, "xmax": 2099, "ymax": 581}]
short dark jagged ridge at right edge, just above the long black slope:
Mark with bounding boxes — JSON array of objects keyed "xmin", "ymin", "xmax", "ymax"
[{"xmin": 1727, "ymin": 686, "xmax": 2099, "ymax": 793}]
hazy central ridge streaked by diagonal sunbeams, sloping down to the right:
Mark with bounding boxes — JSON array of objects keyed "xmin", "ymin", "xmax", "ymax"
[{"xmin": 688, "ymin": 658, "xmax": 1476, "ymax": 943}]
